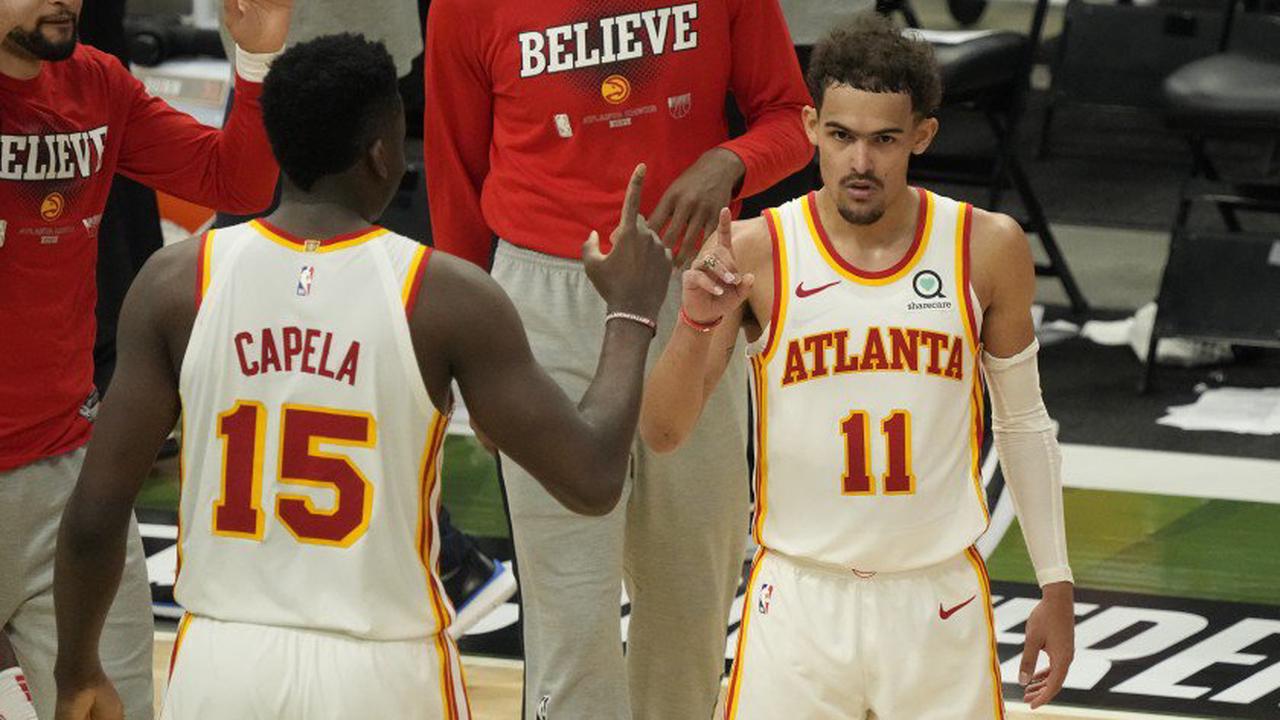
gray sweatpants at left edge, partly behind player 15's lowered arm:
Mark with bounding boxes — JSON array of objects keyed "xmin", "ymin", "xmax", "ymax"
[{"xmin": 0, "ymin": 448, "xmax": 155, "ymax": 720}]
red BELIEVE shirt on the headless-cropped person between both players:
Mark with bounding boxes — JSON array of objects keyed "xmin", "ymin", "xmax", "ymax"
[{"xmin": 425, "ymin": 0, "xmax": 813, "ymax": 266}]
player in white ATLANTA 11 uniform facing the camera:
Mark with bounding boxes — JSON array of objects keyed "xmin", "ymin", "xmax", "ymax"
[{"xmin": 641, "ymin": 15, "xmax": 1073, "ymax": 720}]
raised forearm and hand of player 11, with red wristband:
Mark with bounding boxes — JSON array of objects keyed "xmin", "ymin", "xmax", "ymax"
[{"xmin": 640, "ymin": 209, "xmax": 769, "ymax": 452}]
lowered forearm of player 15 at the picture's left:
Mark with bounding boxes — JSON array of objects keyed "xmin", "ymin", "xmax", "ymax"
[{"xmin": 54, "ymin": 489, "xmax": 132, "ymax": 683}]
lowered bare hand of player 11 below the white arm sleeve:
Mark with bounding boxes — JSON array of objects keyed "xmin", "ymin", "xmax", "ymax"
[{"xmin": 1018, "ymin": 583, "xmax": 1075, "ymax": 710}]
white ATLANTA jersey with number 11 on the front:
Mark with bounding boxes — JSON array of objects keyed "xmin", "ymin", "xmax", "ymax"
[{"xmin": 753, "ymin": 190, "xmax": 987, "ymax": 571}]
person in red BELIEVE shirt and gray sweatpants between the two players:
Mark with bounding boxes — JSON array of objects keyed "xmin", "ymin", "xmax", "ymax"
[{"xmin": 425, "ymin": 0, "xmax": 813, "ymax": 720}]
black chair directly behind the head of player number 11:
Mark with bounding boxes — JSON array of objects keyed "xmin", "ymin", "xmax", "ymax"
[{"xmin": 876, "ymin": 0, "xmax": 1089, "ymax": 315}]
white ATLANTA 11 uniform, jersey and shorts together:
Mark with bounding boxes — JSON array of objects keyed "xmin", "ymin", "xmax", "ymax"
[{"xmin": 726, "ymin": 190, "xmax": 1004, "ymax": 720}]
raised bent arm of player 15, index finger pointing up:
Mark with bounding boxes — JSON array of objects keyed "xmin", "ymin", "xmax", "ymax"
[{"xmin": 412, "ymin": 165, "xmax": 671, "ymax": 515}]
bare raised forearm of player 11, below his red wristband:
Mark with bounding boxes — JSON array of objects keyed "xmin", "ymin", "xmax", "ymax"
[{"xmin": 640, "ymin": 323, "xmax": 714, "ymax": 452}]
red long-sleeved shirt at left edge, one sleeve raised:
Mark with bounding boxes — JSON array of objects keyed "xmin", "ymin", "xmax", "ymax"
[{"xmin": 0, "ymin": 45, "xmax": 279, "ymax": 471}]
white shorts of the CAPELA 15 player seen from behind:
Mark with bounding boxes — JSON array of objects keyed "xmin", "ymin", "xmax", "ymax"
[{"xmin": 160, "ymin": 615, "xmax": 471, "ymax": 720}]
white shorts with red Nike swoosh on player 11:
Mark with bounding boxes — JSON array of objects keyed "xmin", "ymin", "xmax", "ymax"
[{"xmin": 724, "ymin": 548, "xmax": 1005, "ymax": 720}]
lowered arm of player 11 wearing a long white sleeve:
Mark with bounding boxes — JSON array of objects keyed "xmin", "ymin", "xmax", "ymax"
[{"xmin": 972, "ymin": 210, "xmax": 1075, "ymax": 708}]
